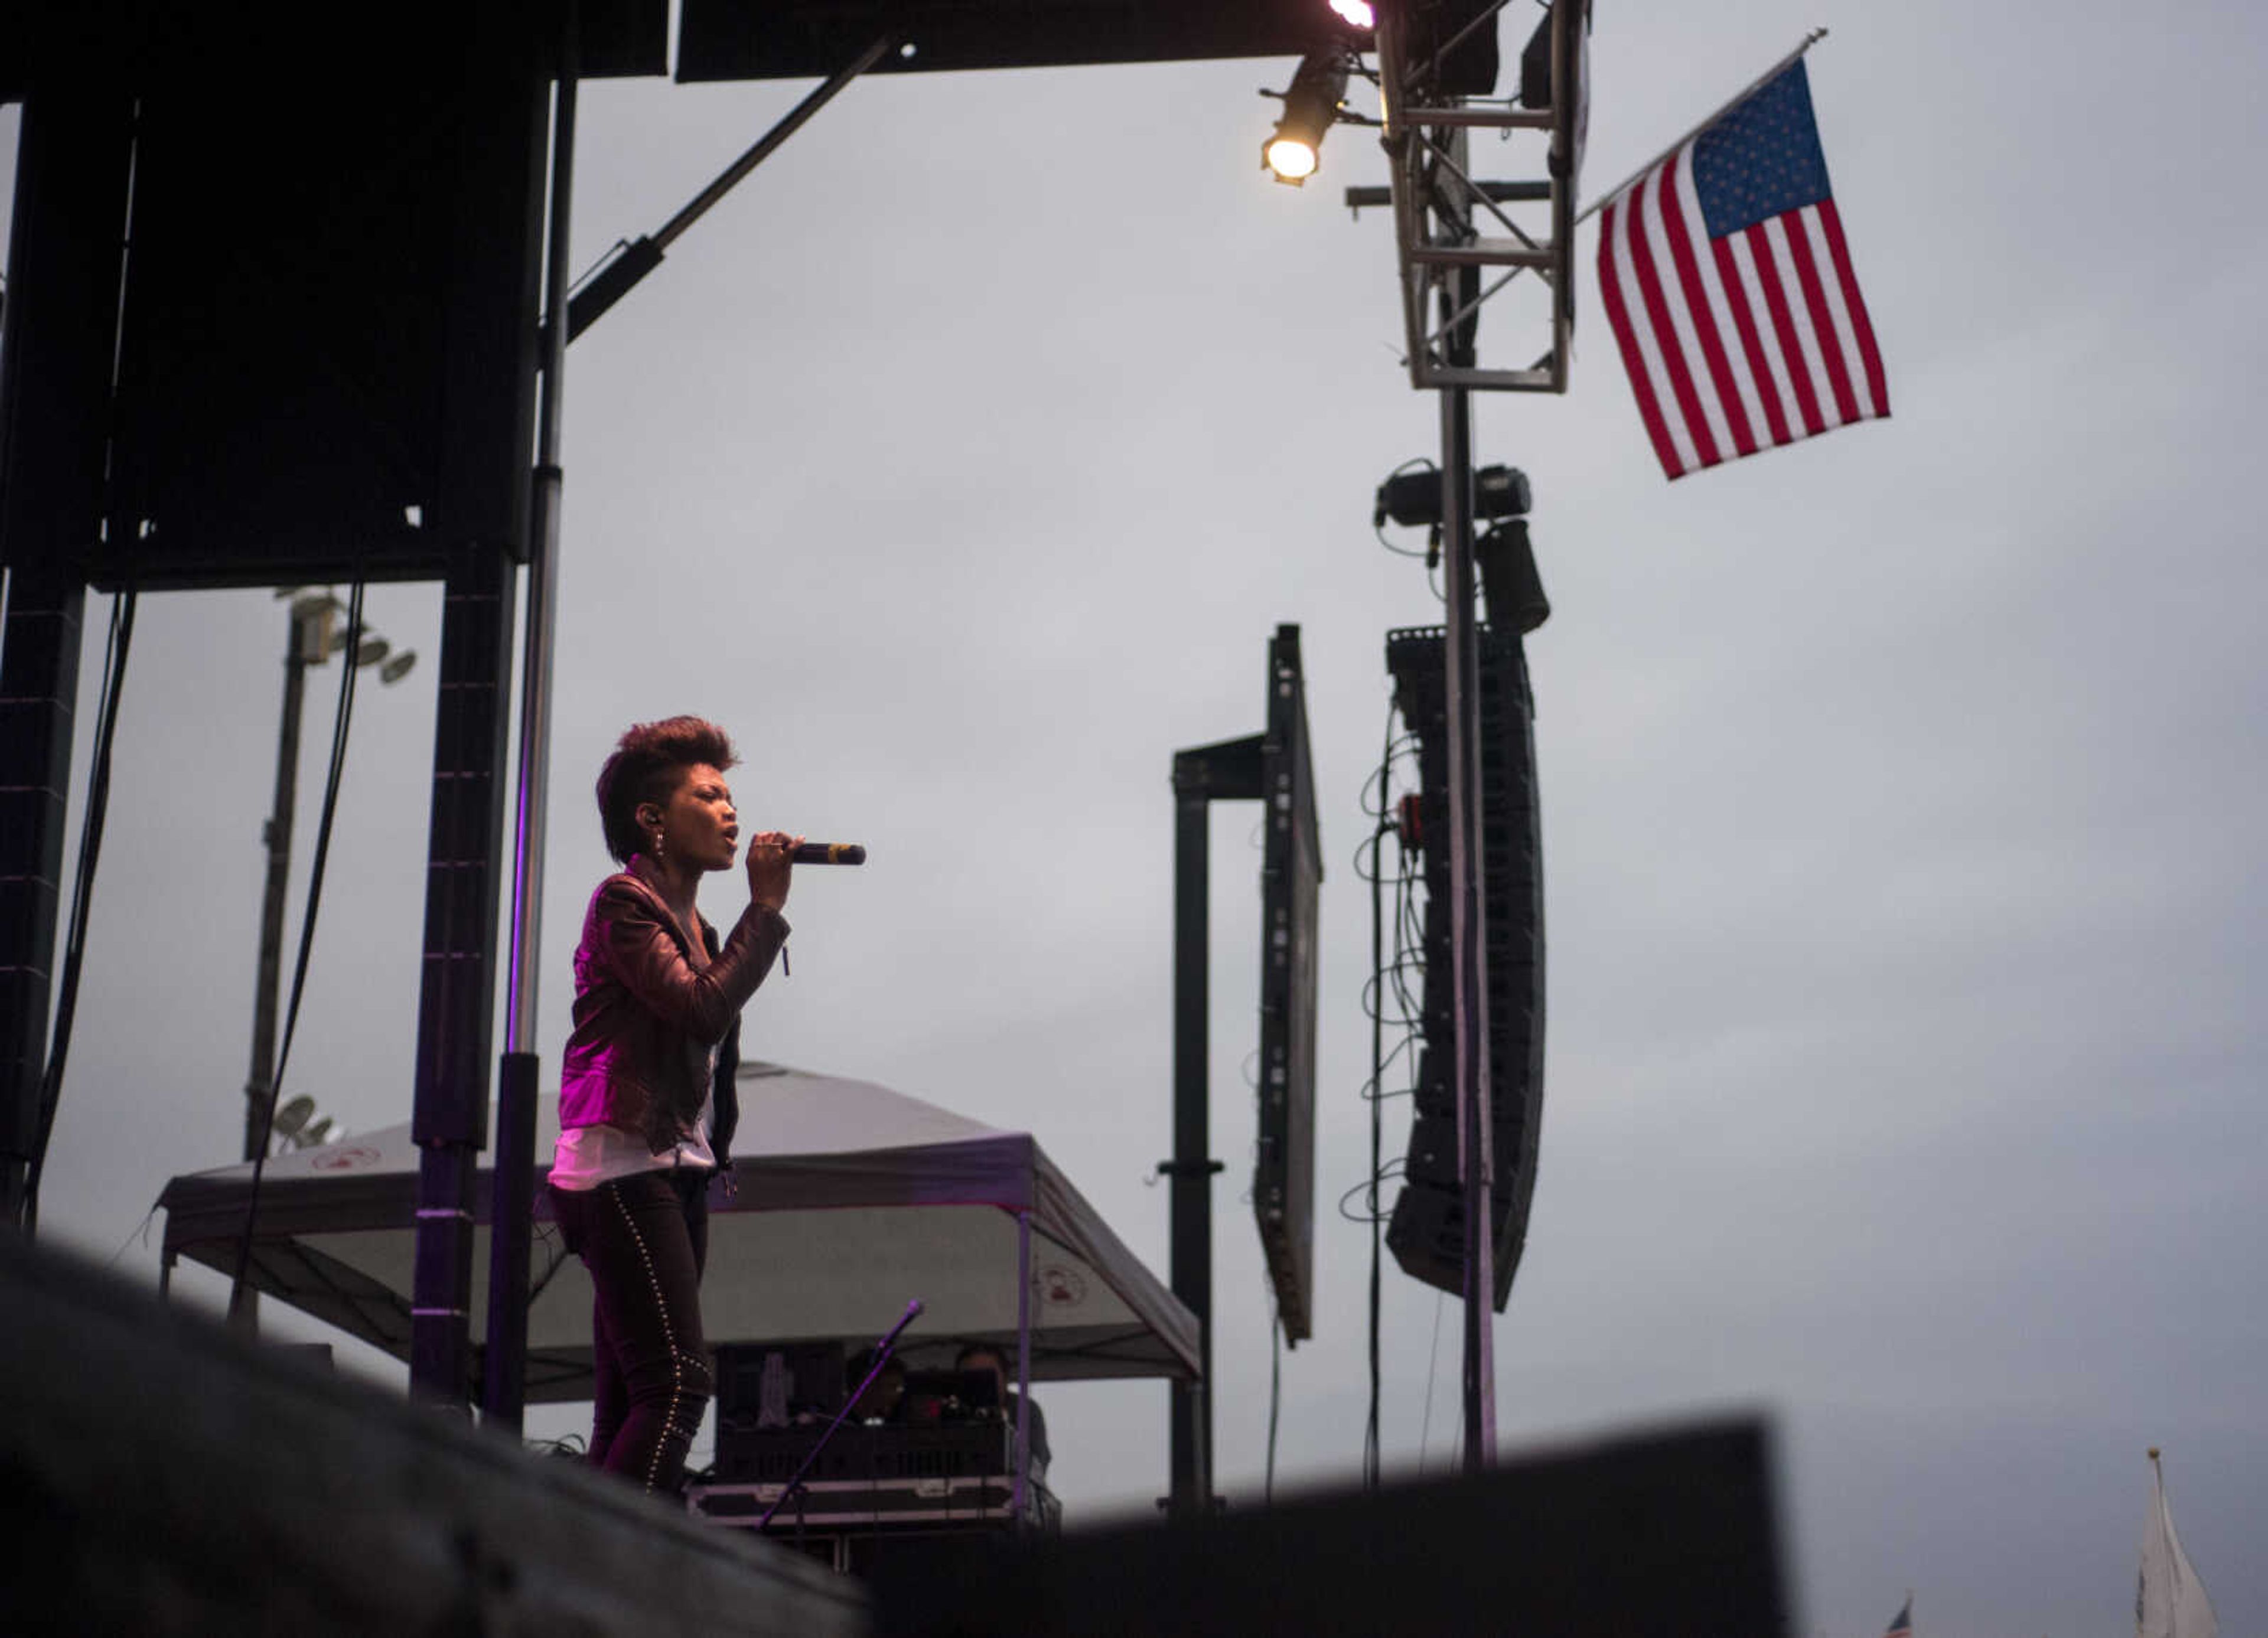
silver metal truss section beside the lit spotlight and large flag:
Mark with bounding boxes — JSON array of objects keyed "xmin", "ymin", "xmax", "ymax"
[{"xmin": 1377, "ymin": 0, "xmax": 1590, "ymax": 393}]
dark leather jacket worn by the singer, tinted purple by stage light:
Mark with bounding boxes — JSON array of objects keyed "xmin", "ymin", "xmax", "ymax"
[{"xmin": 560, "ymin": 860, "xmax": 787, "ymax": 1148}]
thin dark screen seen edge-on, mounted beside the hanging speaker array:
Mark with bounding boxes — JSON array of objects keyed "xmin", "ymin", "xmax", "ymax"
[{"xmin": 1252, "ymin": 626, "xmax": 1322, "ymax": 1343}]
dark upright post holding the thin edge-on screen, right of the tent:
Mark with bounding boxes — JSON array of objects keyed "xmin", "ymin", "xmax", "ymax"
[{"xmin": 1170, "ymin": 771, "xmax": 1220, "ymax": 1518}]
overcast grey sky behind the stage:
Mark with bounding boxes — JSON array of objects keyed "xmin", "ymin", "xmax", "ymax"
[{"xmin": 0, "ymin": 0, "xmax": 2268, "ymax": 1638}]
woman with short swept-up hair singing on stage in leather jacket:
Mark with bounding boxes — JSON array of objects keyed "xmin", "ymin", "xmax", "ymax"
[{"xmin": 551, "ymin": 717, "xmax": 799, "ymax": 1490}]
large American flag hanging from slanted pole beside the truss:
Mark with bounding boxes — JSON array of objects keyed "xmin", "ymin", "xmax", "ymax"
[{"xmin": 1599, "ymin": 57, "xmax": 1889, "ymax": 479}]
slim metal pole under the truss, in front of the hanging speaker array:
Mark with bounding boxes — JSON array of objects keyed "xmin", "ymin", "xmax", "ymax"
[{"xmin": 1440, "ymin": 204, "xmax": 1497, "ymax": 1473}]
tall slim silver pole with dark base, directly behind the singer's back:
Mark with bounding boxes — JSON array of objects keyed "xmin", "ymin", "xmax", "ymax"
[{"xmin": 481, "ymin": 0, "xmax": 581, "ymax": 1431}]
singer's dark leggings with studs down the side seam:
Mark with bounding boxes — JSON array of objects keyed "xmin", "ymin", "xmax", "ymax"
[{"xmin": 551, "ymin": 1169, "xmax": 710, "ymax": 1490}]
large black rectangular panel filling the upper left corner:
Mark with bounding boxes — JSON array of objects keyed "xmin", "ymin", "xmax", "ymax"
[{"xmin": 9, "ymin": 0, "xmax": 558, "ymax": 588}]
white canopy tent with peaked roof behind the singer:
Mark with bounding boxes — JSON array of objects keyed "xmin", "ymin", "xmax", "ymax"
[{"xmin": 159, "ymin": 1064, "xmax": 1198, "ymax": 1402}]
